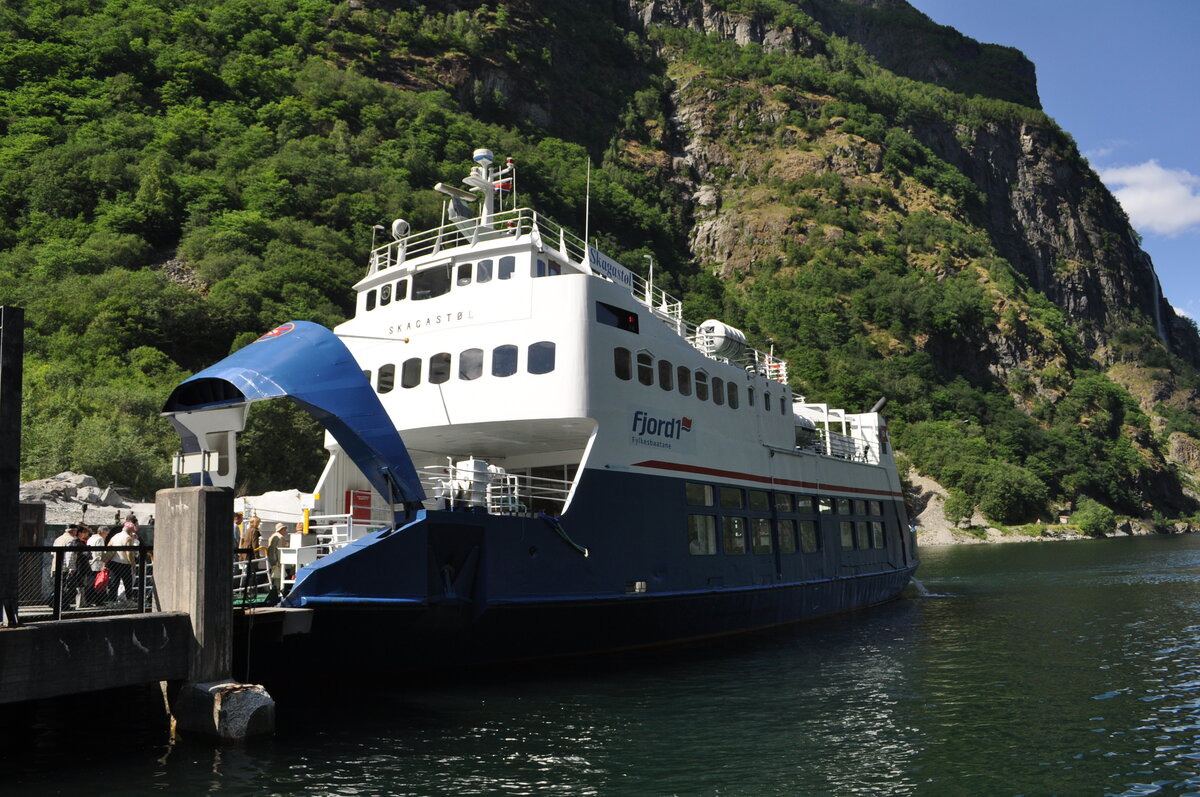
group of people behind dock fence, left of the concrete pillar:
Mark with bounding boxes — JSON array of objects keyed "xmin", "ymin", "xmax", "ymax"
[{"xmin": 46, "ymin": 514, "xmax": 142, "ymax": 609}]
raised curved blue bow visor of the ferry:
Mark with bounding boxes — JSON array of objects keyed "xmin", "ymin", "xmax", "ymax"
[{"xmin": 162, "ymin": 320, "xmax": 425, "ymax": 507}]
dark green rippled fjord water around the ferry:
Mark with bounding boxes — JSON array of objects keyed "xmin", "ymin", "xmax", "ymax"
[{"xmin": 9, "ymin": 535, "xmax": 1200, "ymax": 796}]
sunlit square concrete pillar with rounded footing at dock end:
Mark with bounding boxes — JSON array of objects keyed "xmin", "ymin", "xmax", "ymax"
[{"xmin": 154, "ymin": 487, "xmax": 275, "ymax": 741}]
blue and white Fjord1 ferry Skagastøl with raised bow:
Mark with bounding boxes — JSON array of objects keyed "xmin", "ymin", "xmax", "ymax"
[{"xmin": 164, "ymin": 149, "xmax": 918, "ymax": 669}]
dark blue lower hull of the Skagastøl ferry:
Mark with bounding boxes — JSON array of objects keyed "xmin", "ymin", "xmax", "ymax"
[{"xmin": 278, "ymin": 472, "xmax": 916, "ymax": 670}]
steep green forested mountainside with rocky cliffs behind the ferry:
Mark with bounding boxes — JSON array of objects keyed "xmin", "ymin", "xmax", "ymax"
[{"xmin": 0, "ymin": 0, "xmax": 1200, "ymax": 523}]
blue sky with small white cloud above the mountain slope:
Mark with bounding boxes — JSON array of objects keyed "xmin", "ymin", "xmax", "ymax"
[{"xmin": 908, "ymin": 0, "xmax": 1200, "ymax": 320}]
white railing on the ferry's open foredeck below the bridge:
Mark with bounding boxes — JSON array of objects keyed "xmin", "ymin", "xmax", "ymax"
[{"xmin": 419, "ymin": 465, "xmax": 571, "ymax": 516}]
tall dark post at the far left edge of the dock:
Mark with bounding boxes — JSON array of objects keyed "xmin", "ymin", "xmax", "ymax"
[{"xmin": 0, "ymin": 306, "xmax": 25, "ymax": 625}]
